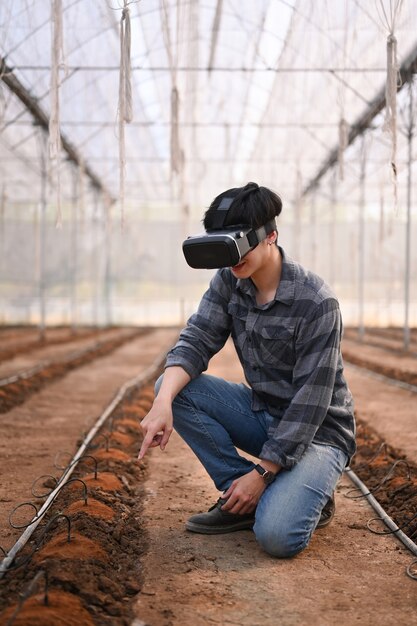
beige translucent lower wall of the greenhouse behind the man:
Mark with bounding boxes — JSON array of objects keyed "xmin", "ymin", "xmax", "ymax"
[{"xmin": 0, "ymin": 204, "xmax": 417, "ymax": 326}]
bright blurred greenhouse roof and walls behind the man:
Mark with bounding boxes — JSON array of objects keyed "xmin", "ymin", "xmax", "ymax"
[{"xmin": 0, "ymin": 0, "xmax": 417, "ymax": 337}]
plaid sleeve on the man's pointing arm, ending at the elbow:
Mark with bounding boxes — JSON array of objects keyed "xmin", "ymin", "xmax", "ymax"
[{"xmin": 165, "ymin": 270, "xmax": 232, "ymax": 378}]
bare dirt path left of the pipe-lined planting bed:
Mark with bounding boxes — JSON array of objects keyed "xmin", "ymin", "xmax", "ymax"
[{"xmin": 0, "ymin": 329, "xmax": 177, "ymax": 549}]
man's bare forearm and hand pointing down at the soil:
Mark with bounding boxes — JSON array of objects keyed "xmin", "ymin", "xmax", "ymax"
[{"xmin": 138, "ymin": 366, "xmax": 191, "ymax": 459}]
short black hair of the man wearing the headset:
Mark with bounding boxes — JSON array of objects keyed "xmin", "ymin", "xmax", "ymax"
[{"xmin": 203, "ymin": 183, "xmax": 282, "ymax": 230}]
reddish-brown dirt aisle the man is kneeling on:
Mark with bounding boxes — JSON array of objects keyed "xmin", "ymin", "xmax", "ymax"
[{"xmin": 135, "ymin": 338, "xmax": 417, "ymax": 626}]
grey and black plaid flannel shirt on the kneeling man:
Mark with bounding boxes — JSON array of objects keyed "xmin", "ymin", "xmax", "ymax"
[{"xmin": 166, "ymin": 248, "xmax": 355, "ymax": 469}]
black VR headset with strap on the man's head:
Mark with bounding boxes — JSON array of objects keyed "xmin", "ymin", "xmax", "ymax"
[{"xmin": 182, "ymin": 198, "xmax": 276, "ymax": 269}]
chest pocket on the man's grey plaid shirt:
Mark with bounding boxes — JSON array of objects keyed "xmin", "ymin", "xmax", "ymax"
[{"xmin": 255, "ymin": 325, "xmax": 295, "ymax": 367}]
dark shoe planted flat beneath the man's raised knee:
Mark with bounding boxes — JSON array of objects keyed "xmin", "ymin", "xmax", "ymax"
[{"xmin": 185, "ymin": 498, "xmax": 255, "ymax": 535}]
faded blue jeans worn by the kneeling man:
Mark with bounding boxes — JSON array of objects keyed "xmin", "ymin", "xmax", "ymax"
[{"xmin": 155, "ymin": 374, "xmax": 347, "ymax": 557}]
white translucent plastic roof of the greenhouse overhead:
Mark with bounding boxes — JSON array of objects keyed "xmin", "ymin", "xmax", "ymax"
[{"xmin": 0, "ymin": 0, "xmax": 417, "ymax": 218}]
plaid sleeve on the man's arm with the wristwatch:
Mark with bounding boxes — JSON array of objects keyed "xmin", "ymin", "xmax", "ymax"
[{"xmin": 260, "ymin": 298, "xmax": 341, "ymax": 469}]
